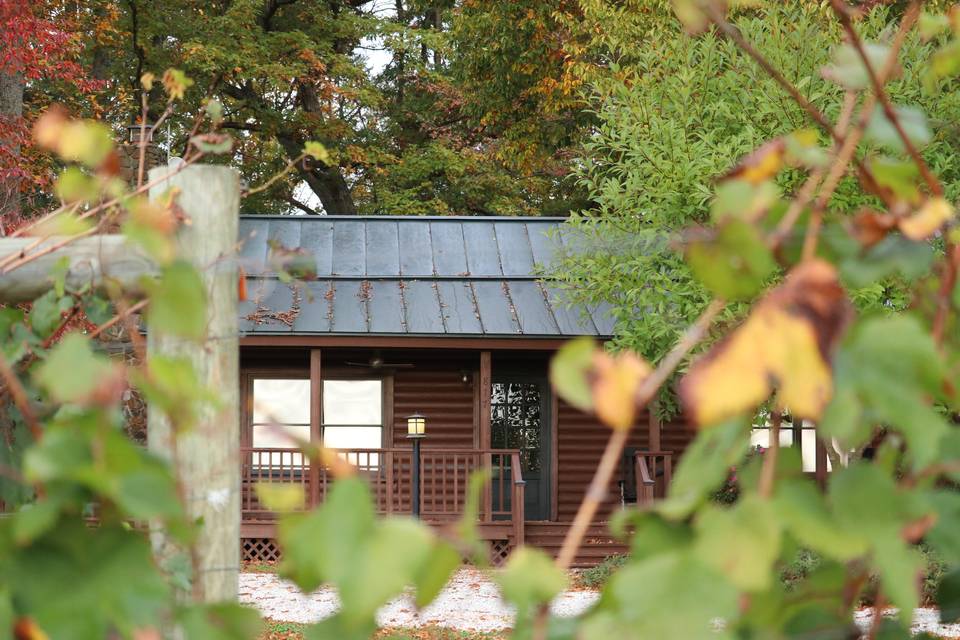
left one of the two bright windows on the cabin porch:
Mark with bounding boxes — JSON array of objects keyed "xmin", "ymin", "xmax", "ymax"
[{"xmin": 251, "ymin": 378, "xmax": 310, "ymax": 466}]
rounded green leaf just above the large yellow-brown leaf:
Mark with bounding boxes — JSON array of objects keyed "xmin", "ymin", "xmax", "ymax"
[{"xmin": 685, "ymin": 220, "xmax": 777, "ymax": 300}]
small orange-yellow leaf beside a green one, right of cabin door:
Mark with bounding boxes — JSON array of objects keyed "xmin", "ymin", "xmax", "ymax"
[{"xmin": 593, "ymin": 351, "xmax": 650, "ymax": 431}]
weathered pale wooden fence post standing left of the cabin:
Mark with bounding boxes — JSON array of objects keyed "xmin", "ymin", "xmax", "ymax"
[{"xmin": 147, "ymin": 165, "xmax": 240, "ymax": 602}]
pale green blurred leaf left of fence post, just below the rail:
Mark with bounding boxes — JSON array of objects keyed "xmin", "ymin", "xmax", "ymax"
[{"xmin": 34, "ymin": 333, "xmax": 113, "ymax": 403}]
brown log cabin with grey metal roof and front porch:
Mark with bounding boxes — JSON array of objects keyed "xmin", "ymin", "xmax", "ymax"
[{"xmin": 239, "ymin": 216, "xmax": 692, "ymax": 566}]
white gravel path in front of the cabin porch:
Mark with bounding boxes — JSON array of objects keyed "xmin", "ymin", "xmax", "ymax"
[{"xmin": 240, "ymin": 569, "xmax": 599, "ymax": 631}]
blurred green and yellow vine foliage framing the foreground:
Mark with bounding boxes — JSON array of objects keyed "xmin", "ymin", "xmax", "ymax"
[{"xmin": 0, "ymin": 0, "xmax": 960, "ymax": 640}]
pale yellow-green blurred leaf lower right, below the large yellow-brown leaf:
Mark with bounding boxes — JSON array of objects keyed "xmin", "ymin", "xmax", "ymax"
[{"xmin": 695, "ymin": 495, "xmax": 781, "ymax": 591}]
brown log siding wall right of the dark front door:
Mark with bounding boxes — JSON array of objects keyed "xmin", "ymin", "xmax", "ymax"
[{"xmin": 557, "ymin": 401, "xmax": 693, "ymax": 522}]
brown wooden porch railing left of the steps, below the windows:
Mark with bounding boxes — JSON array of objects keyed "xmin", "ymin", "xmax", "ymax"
[{"xmin": 241, "ymin": 447, "xmax": 524, "ymax": 528}]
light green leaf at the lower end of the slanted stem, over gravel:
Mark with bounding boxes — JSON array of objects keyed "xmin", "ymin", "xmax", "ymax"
[{"xmin": 497, "ymin": 546, "xmax": 567, "ymax": 617}]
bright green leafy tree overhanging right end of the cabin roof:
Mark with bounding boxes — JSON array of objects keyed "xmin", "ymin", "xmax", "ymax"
[{"xmin": 559, "ymin": 3, "xmax": 960, "ymax": 380}]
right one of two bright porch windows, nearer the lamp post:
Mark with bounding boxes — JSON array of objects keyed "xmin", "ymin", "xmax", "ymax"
[{"xmin": 322, "ymin": 380, "xmax": 383, "ymax": 449}]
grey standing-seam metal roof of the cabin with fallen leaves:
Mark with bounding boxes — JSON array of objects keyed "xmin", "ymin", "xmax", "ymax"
[{"xmin": 240, "ymin": 215, "xmax": 613, "ymax": 338}]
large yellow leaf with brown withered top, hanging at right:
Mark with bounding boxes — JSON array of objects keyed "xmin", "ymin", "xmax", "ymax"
[{"xmin": 680, "ymin": 260, "xmax": 851, "ymax": 425}]
